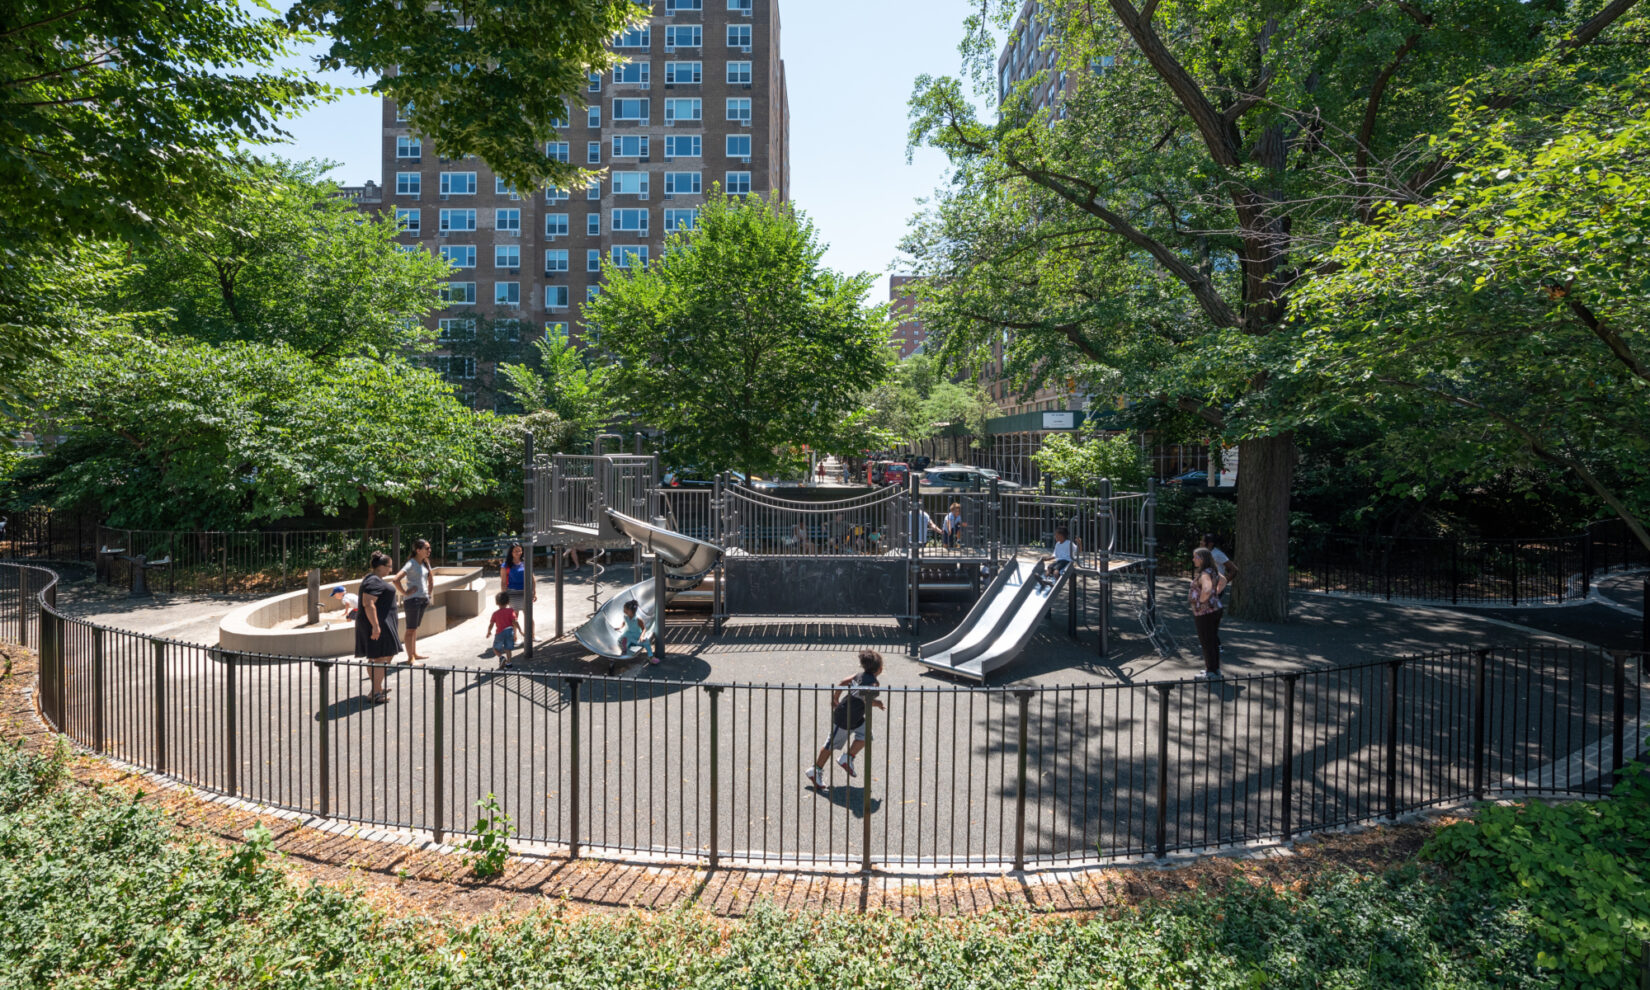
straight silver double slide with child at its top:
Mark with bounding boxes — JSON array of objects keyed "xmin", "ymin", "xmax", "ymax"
[{"xmin": 917, "ymin": 561, "xmax": 1076, "ymax": 681}]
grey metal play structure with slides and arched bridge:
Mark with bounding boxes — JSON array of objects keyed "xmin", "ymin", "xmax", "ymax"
[{"xmin": 523, "ymin": 437, "xmax": 1173, "ymax": 681}]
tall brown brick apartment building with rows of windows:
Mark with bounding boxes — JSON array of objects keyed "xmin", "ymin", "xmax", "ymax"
[{"xmin": 383, "ymin": 0, "xmax": 790, "ymax": 408}]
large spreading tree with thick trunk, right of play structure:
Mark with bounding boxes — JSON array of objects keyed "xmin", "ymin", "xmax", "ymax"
[{"xmin": 908, "ymin": 0, "xmax": 1634, "ymax": 620}]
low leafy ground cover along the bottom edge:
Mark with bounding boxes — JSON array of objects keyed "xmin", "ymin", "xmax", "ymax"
[{"xmin": 0, "ymin": 747, "xmax": 1647, "ymax": 988}]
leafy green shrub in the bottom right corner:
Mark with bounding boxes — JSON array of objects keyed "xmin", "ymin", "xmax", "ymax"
[{"xmin": 1422, "ymin": 764, "xmax": 1650, "ymax": 987}]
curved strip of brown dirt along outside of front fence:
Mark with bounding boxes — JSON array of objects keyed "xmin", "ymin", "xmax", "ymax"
[{"xmin": 0, "ymin": 644, "xmax": 1452, "ymax": 917}]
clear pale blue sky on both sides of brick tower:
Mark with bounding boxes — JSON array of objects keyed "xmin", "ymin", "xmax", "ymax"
[{"xmin": 276, "ymin": 0, "xmax": 990, "ymax": 300}]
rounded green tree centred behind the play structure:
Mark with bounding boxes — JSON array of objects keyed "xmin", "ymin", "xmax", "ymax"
[{"xmin": 584, "ymin": 188, "xmax": 889, "ymax": 474}]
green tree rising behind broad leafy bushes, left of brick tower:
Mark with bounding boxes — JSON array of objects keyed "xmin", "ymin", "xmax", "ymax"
[{"xmin": 112, "ymin": 160, "xmax": 450, "ymax": 358}]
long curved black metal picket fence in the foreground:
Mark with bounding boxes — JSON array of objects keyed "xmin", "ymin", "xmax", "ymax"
[{"xmin": 12, "ymin": 564, "xmax": 1647, "ymax": 870}]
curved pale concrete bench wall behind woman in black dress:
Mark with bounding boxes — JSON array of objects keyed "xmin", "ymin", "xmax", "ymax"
[{"xmin": 218, "ymin": 568, "xmax": 487, "ymax": 657}]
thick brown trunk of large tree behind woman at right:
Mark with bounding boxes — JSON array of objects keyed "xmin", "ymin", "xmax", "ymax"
[{"xmin": 1231, "ymin": 432, "xmax": 1295, "ymax": 622}]
